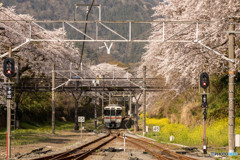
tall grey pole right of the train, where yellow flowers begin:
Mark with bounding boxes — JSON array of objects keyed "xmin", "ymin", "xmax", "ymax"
[{"xmin": 143, "ymin": 66, "xmax": 146, "ymax": 136}]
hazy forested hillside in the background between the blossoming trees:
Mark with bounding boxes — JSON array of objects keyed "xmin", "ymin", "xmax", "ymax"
[{"xmin": 2, "ymin": 0, "xmax": 160, "ymax": 64}]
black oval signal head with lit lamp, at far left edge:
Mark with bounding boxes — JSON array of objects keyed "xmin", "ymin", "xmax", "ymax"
[{"xmin": 3, "ymin": 58, "xmax": 15, "ymax": 78}]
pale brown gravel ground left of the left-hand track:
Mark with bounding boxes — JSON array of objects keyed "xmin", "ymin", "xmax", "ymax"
[{"xmin": 0, "ymin": 131, "xmax": 104, "ymax": 159}]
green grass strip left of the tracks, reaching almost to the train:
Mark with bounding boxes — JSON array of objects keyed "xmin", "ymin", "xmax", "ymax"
[{"xmin": 0, "ymin": 119, "xmax": 102, "ymax": 147}]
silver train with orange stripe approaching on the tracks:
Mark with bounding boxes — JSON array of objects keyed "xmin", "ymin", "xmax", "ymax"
[{"xmin": 104, "ymin": 104, "xmax": 125, "ymax": 128}]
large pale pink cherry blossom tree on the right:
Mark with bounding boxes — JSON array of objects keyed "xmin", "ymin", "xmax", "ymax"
[{"xmin": 139, "ymin": 0, "xmax": 240, "ymax": 91}]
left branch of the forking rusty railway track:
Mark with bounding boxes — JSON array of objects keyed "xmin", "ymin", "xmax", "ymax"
[{"xmin": 33, "ymin": 131, "xmax": 119, "ymax": 160}]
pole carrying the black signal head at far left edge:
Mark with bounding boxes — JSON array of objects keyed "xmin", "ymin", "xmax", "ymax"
[{"xmin": 7, "ymin": 48, "xmax": 12, "ymax": 159}]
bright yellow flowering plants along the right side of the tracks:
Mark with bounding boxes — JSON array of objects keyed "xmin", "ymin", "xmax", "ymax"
[{"xmin": 142, "ymin": 118, "xmax": 240, "ymax": 147}]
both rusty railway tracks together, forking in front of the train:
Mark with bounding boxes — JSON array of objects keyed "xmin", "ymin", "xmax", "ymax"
[{"xmin": 33, "ymin": 130, "xmax": 196, "ymax": 160}]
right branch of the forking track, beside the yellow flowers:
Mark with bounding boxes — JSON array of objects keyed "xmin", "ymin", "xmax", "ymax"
[{"xmin": 118, "ymin": 136, "xmax": 196, "ymax": 160}]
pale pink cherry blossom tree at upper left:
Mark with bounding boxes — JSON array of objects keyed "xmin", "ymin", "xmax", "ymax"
[{"xmin": 0, "ymin": 7, "xmax": 84, "ymax": 75}]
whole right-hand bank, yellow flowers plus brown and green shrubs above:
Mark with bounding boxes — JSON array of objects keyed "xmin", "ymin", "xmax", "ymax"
[{"xmin": 142, "ymin": 74, "xmax": 240, "ymax": 147}]
